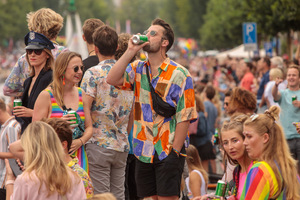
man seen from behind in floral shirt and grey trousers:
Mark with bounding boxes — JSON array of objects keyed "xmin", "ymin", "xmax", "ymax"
[{"xmin": 81, "ymin": 26, "xmax": 133, "ymax": 200}]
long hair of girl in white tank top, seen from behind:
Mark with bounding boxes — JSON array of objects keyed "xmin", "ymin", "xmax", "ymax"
[{"xmin": 186, "ymin": 144, "xmax": 208, "ymax": 186}]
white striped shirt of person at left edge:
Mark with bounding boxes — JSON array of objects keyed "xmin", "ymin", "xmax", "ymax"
[{"xmin": 0, "ymin": 116, "xmax": 21, "ymax": 188}]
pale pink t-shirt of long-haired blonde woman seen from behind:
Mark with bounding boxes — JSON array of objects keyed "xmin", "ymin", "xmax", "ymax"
[{"xmin": 10, "ymin": 172, "xmax": 86, "ymax": 200}]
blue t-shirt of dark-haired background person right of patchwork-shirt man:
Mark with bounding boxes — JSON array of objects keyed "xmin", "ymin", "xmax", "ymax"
[{"xmin": 204, "ymin": 101, "xmax": 218, "ymax": 138}]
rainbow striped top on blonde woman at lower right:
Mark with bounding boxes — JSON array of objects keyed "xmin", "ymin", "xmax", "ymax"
[{"xmin": 240, "ymin": 161, "xmax": 286, "ymax": 200}]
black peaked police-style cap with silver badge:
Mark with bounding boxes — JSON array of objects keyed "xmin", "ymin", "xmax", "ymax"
[{"xmin": 24, "ymin": 31, "xmax": 54, "ymax": 50}]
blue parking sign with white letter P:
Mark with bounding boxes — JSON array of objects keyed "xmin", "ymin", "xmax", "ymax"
[{"xmin": 243, "ymin": 22, "xmax": 257, "ymax": 51}]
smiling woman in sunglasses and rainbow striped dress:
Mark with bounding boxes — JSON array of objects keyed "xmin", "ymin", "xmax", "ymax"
[{"xmin": 32, "ymin": 51, "xmax": 93, "ymax": 172}]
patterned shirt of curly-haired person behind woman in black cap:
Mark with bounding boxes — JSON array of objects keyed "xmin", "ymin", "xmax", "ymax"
[{"xmin": 3, "ymin": 43, "xmax": 69, "ymax": 96}]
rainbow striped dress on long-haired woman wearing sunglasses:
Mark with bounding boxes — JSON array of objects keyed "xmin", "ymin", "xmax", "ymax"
[{"xmin": 46, "ymin": 87, "xmax": 89, "ymax": 172}]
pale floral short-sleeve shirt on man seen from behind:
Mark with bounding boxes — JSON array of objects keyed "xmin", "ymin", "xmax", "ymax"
[{"xmin": 81, "ymin": 60, "xmax": 133, "ymax": 152}]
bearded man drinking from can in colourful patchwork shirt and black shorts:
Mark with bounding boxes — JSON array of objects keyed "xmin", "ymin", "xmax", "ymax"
[{"xmin": 107, "ymin": 19, "xmax": 197, "ymax": 199}]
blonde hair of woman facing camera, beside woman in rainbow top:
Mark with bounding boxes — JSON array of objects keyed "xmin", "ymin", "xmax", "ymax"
[{"xmin": 220, "ymin": 114, "xmax": 248, "ymax": 165}]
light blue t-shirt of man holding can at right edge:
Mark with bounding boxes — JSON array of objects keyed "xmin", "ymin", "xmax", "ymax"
[{"xmin": 278, "ymin": 89, "xmax": 300, "ymax": 139}]
